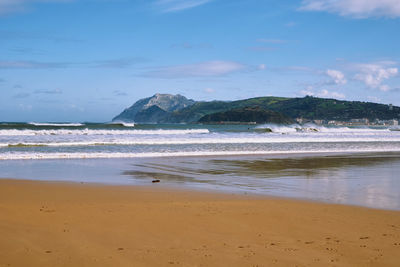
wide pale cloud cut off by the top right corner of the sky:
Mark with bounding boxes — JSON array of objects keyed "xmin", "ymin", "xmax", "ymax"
[{"xmin": 300, "ymin": 0, "xmax": 400, "ymax": 18}]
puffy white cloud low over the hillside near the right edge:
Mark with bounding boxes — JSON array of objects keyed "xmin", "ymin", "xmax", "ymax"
[{"xmin": 354, "ymin": 61, "xmax": 399, "ymax": 92}]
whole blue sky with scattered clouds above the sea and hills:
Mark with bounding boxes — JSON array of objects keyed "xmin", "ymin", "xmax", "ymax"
[{"xmin": 0, "ymin": 0, "xmax": 400, "ymax": 122}]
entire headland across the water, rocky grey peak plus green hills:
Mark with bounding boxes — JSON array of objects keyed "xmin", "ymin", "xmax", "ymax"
[{"xmin": 114, "ymin": 94, "xmax": 400, "ymax": 123}]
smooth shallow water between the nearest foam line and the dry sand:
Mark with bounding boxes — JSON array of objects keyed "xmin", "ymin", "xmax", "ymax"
[{"xmin": 0, "ymin": 152, "xmax": 400, "ymax": 210}]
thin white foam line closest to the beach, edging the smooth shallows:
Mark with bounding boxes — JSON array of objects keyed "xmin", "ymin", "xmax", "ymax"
[{"xmin": 0, "ymin": 148, "xmax": 400, "ymax": 160}]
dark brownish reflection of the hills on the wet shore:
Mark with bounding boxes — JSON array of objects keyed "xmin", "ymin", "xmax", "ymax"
[{"xmin": 123, "ymin": 154, "xmax": 400, "ymax": 182}]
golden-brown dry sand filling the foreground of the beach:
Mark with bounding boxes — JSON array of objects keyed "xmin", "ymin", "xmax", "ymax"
[{"xmin": 0, "ymin": 180, "xmax": 400, "ymax": 266}]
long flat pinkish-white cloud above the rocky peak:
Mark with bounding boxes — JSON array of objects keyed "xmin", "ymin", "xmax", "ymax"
[{"xmin": 144, "ymin": 61, "xmax": 247, "ymax": 78}]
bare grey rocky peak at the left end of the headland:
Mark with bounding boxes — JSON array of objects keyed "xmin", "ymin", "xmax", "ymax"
[{"xmin": 113, "ymin": 94, "xmax": 195, "ymax": 123}]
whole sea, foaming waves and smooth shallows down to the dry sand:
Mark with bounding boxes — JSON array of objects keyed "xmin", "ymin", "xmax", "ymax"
[{"xmin": 0, "ymin": 122, "xmax": 400, "ymax": 210}]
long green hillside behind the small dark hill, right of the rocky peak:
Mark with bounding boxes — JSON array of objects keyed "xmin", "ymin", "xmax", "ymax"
[{"xmin": 164, "ymin": 96, "xmax": 400, "ymax": 123}]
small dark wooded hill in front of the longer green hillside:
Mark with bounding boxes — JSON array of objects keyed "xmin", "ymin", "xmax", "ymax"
[{"xmin": 198, "ymin": 106, "xmax": 294, "ymax": 124}]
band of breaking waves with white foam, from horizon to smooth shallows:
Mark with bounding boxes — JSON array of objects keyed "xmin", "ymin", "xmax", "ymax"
[{"xmin": 0, "ymin": 123, "xmax": 400, "ymax": 160}]
